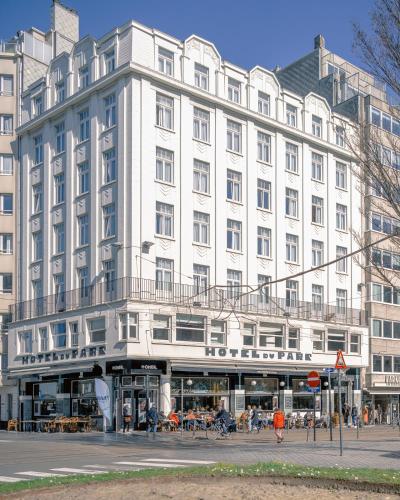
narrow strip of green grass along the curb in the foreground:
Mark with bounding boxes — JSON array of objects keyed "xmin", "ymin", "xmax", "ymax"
[{"xmin": 0, "ymin": 462, "xmax": 400, "ymax": 494}]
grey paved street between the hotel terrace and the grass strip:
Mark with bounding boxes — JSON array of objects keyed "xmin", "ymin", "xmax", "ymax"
[{"xmin": 0, "ymin": 426, "xmax": 400, "ymax": 482}]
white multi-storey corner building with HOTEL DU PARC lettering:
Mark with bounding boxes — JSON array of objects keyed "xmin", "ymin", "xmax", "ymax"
[{"xmin": 8, "ymin": 9, "xmax": 368, "ymax": 425}]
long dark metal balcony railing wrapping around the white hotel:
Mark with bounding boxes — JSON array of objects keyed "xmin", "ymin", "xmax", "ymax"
[{"xmin": 10, "ymin": 277, "xmax": 366, "ymax": 326}]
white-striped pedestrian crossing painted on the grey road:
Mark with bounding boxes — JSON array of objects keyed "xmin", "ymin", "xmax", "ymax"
[{"xmin": 0, "ymin": 458, "xmax": 215, "ymax": 483}]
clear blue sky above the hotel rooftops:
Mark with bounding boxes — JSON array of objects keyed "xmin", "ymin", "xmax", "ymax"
[{"xmin": 0, "ymin": 0, "xmax": 373, "ymax": 69}]
